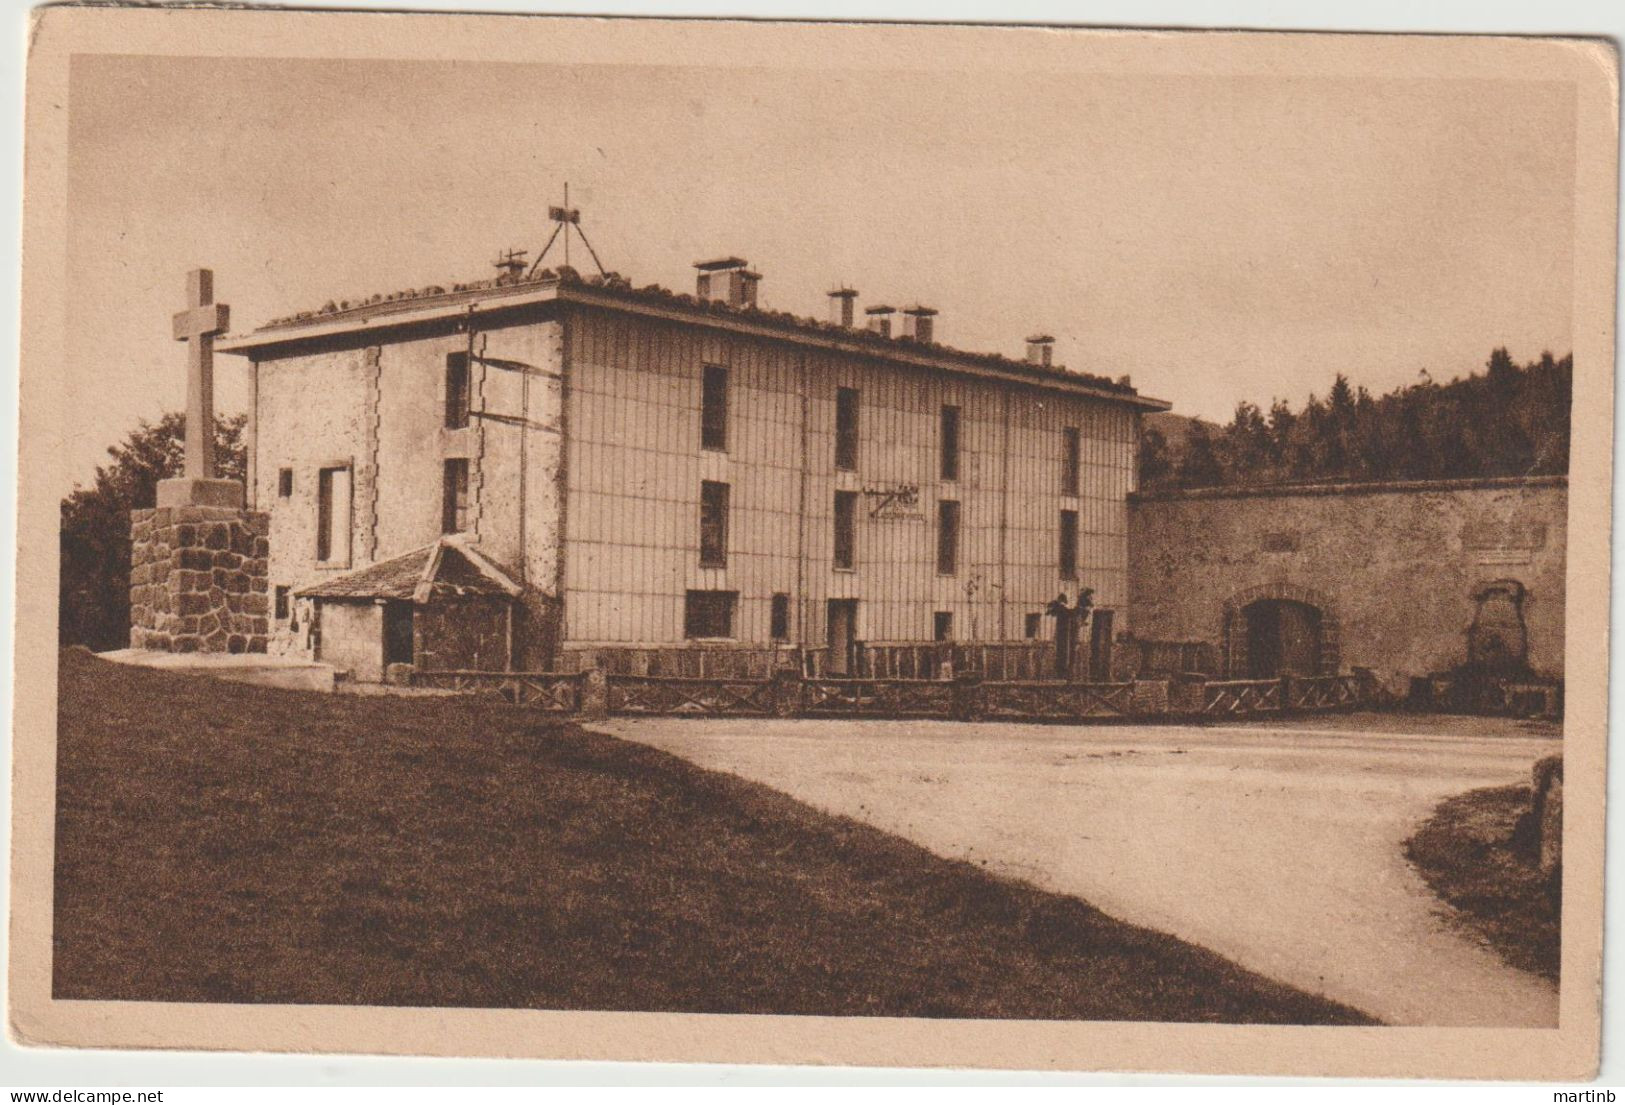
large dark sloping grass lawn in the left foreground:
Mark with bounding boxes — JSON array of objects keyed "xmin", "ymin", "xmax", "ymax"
[{"xmin": 54, "ymin": 650, "xmax": 1368, "ymax": 1024}]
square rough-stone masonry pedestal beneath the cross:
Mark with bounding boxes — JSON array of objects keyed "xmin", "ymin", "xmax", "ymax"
[{"xmin": 130, "ymin": 505, "xmax": 270, "ymax": 652}]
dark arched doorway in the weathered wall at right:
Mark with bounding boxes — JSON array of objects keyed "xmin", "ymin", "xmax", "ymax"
[{"xmin": 1222, "ymin": 583, "xmax": 1342, "ymax": 679}]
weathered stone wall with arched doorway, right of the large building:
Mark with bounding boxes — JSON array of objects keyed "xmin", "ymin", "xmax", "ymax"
[{"xmin": 1128, "ymin": 478, "xmax": 1568, "ymax": 692}]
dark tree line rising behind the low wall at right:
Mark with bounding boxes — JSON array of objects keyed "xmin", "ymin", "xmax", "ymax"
[{"xmin": 1139, "ymin": 348, "xmax": 1575, "ymax": 491}]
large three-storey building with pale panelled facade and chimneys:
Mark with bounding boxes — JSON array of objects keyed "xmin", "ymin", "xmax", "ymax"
[{"xmin": 216, "ymin": 258, "xmax": 1168, "ymax": 679}]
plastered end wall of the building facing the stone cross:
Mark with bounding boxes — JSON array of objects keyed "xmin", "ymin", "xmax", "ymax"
[{"xmin": 252, "ymin": 320, "xmax": 564, "ymax": 668}]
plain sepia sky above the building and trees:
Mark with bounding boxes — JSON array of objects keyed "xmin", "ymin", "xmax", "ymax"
[{"xmin": 62, "ymin": 55, "xmax": 1575, "ymax": 491}]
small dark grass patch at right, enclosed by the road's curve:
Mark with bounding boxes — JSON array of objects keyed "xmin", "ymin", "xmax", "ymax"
[{"xmin": 1406, "ymin": 787, "xmax": 1562, "ymax": 982}]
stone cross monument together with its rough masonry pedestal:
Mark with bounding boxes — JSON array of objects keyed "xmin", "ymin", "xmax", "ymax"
[{"xmin": 130, "ymin": 268, "xmax": 270, "ymax": 653}]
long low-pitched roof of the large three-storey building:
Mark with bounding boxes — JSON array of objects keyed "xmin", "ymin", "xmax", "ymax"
[{"xmin": 254, "ymin": 265, "xmax": 1155, "ymax": 403}]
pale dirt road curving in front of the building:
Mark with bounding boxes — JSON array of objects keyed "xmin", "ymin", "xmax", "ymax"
[{"xmin": 596, "ymin": 718, "xmax": 1560, "ymax": 1027}]
